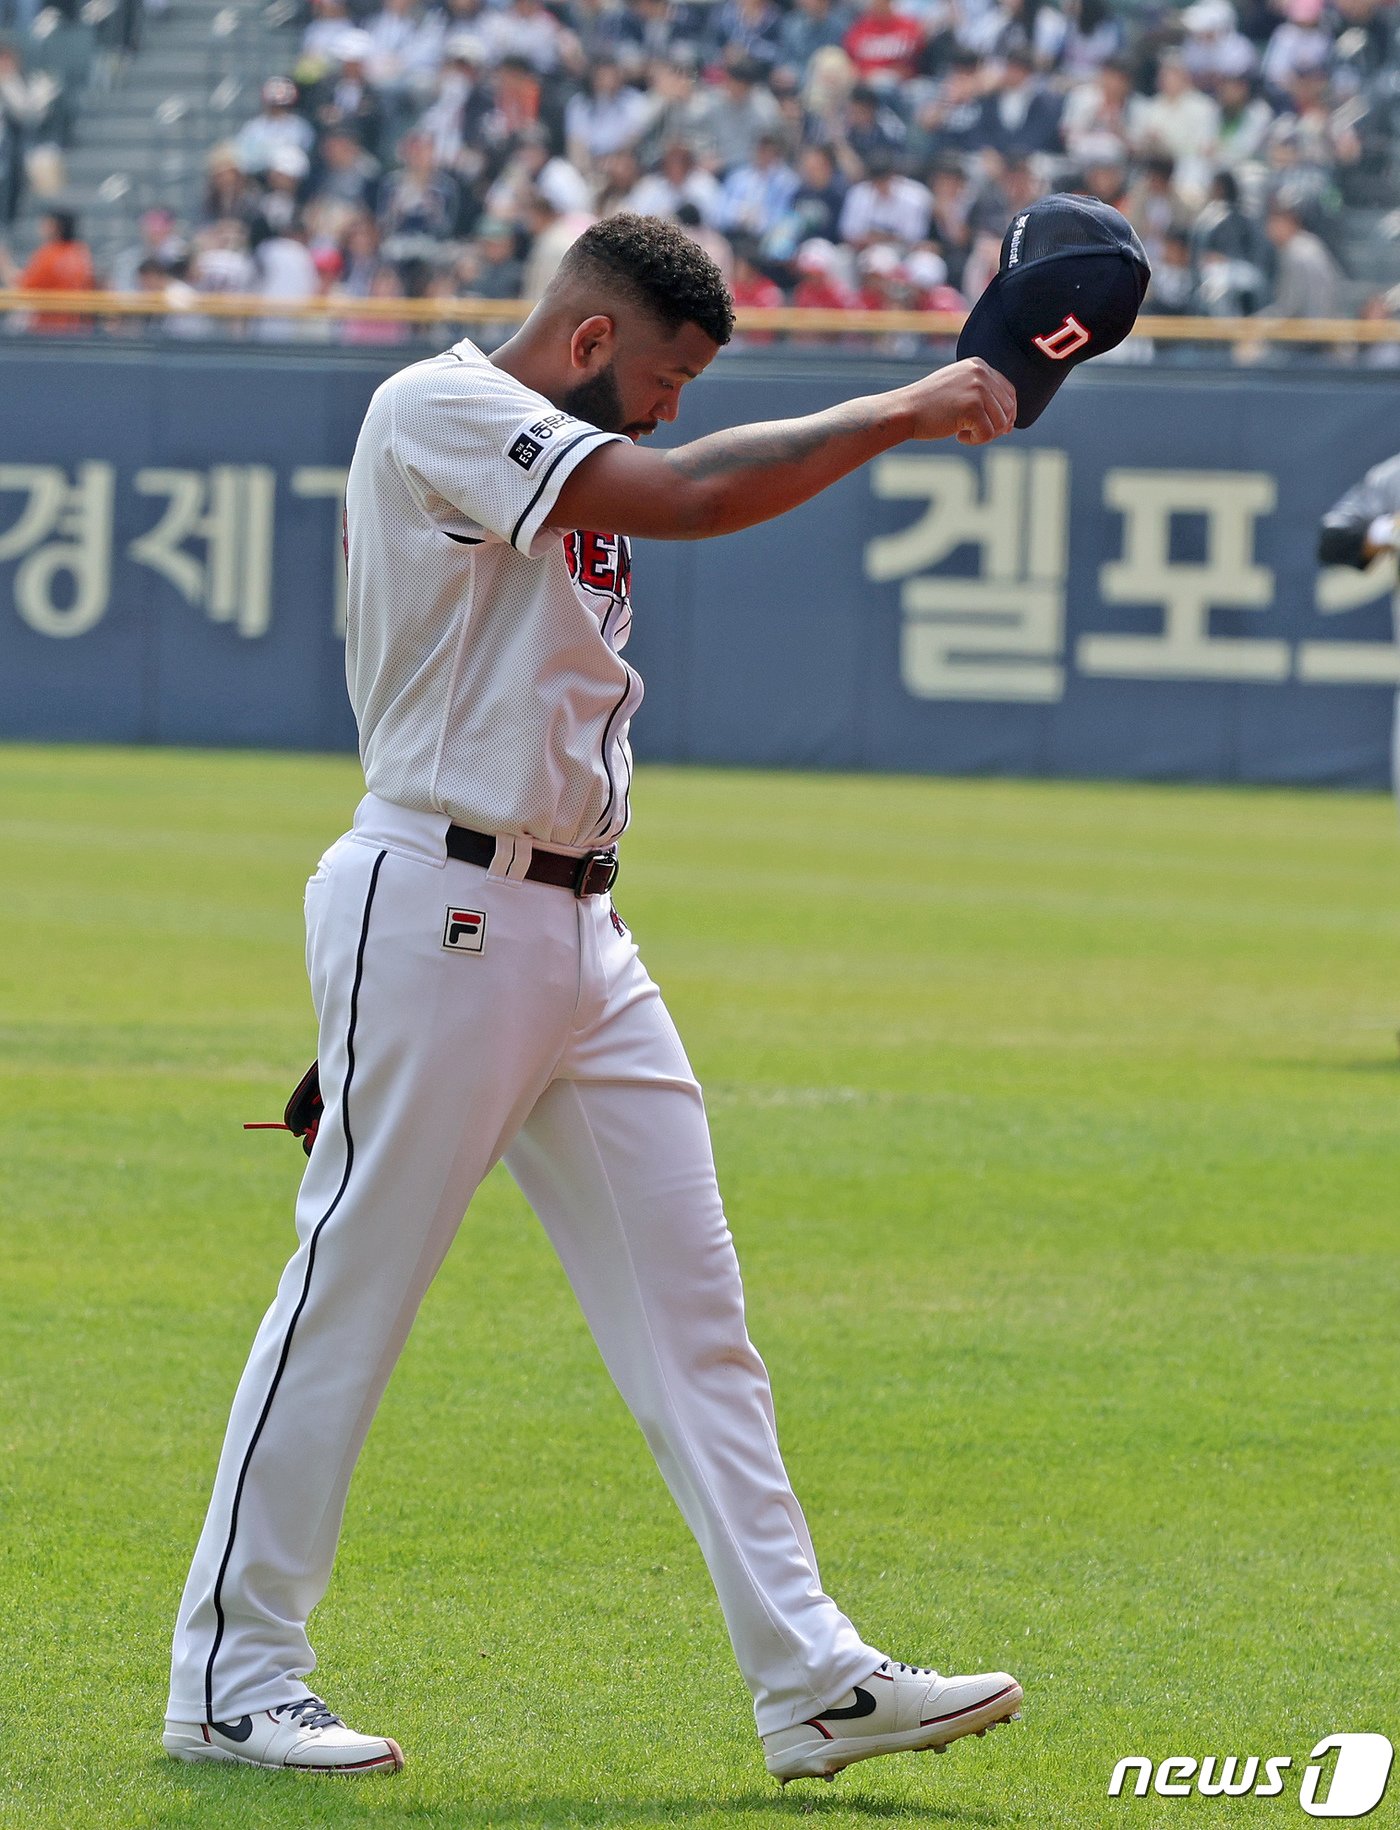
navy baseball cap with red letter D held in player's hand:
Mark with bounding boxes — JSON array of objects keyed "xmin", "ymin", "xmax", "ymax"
[{"xmin": 957, "ymin": 196, "xmax": 1151, "ymax": 426}]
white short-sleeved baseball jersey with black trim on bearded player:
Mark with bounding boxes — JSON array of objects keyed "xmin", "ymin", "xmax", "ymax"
[{"xmin": 346, "ymin": 342, "xmax": 642, "ymax": 851}]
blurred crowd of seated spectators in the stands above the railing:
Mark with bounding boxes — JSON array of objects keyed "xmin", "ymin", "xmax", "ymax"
[{"xmin": 0, "ymin": 0, "xmax": 1400, "ymax": 340}]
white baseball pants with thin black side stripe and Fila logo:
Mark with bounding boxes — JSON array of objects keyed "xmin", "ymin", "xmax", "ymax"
[{"xmin": 168, "ymin": 796, "xmax": 882, "ymax": 1735}]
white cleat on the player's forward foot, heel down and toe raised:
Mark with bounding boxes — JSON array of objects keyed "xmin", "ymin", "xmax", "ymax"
[{"xmin": 763, "ymin": 1658, "xmax": 1021, "ymax": 1784}]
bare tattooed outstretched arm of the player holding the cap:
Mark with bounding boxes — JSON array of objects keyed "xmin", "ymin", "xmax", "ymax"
[{"xmin": 551, "ymin": 359, "xmax": 1016, "ymax": 540}]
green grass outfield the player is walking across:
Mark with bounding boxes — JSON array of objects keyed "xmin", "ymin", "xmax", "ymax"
[{"xmin": 0, "ymin": 748, "xmax": 1400, "ymax": 1830}]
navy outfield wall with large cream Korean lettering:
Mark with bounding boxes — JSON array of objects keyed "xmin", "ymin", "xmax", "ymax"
[{"xmin": 0, "ymin": 342, "xmax": 1400, "ymax": 785}]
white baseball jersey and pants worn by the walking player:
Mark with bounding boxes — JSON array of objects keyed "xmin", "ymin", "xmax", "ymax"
[{"xmin": 168, "ymin": 342, "xmax": 882, "ymax": 1735}]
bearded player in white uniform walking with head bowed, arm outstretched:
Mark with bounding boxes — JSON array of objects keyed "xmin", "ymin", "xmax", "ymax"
[{"xmin": 163, "ymin": 216, "xmax": 1021, "ymax": 1781}]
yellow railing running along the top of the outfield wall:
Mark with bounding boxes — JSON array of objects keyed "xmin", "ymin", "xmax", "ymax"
[{"xmin": 0, "ymin": 289, "xmax": 1400, "ymax": 351}]
